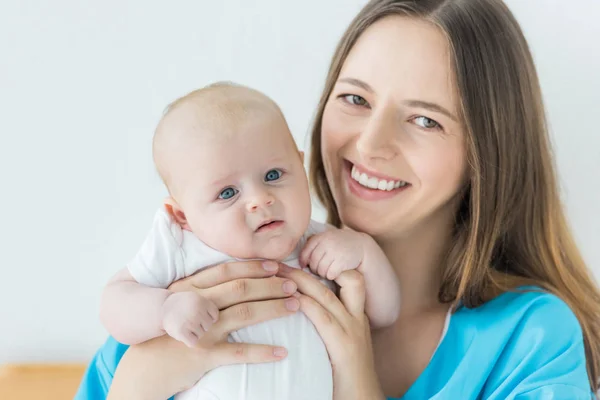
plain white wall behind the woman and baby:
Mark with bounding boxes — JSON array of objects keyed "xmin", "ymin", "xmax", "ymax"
[{"xmin": 0, "ymin": 0, "xmax": 600, "ymax": 363}]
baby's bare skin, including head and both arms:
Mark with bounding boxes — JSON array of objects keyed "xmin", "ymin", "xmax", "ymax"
[{"xmin": 100, "ymin": 87, "xmax": 400, "ymax": 347}]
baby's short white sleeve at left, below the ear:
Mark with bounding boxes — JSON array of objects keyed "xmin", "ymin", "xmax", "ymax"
[{"xmin": 127, "ymin": 208, "xmax": 185, "ymax": 288}]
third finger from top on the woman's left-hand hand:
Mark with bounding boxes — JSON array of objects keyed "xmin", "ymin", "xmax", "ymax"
[{"xmin": 210, "ymin": 297, "xmax": 300, "ymax": 340}]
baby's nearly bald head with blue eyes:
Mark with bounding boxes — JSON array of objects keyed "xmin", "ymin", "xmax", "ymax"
[{"xmin": 153, "ymin": 83, "xmax": 311, "ymax": 260}]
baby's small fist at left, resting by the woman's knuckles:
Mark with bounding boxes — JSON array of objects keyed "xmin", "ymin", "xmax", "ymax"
[{"xmin": 162, "ymin": 292, "xmax": 219, "ymax": 347}]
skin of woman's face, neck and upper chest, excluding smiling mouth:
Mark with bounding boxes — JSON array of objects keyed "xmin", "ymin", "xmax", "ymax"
[{"xmin": 322, "ymin": 17, "xmax": 466, "ymax": 396}]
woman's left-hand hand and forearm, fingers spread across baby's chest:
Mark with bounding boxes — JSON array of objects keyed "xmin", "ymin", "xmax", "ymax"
[{"xmin": 109, "ymin": 261, "xmax": 299, "ymax": 400}]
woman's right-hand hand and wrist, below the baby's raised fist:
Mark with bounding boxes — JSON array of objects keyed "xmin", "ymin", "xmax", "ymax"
[{"xmin": 278, "ymin": 266, "xmax": 385, "ymax": 400}]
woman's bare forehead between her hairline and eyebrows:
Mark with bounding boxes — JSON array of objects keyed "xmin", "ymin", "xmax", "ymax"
[{"xmin": 339, "ymin": 16, "xmax": 455, "ymax": 109}]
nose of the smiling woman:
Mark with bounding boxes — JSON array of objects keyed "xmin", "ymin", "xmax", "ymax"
[{"xmin": 356, "ymin": 109, "xmax": 400, "ymax": 160}]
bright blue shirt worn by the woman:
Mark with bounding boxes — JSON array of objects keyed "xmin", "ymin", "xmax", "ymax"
[{"xmin": 75, "ymin": 291, "xmax": 594, "ymax": 400}]
